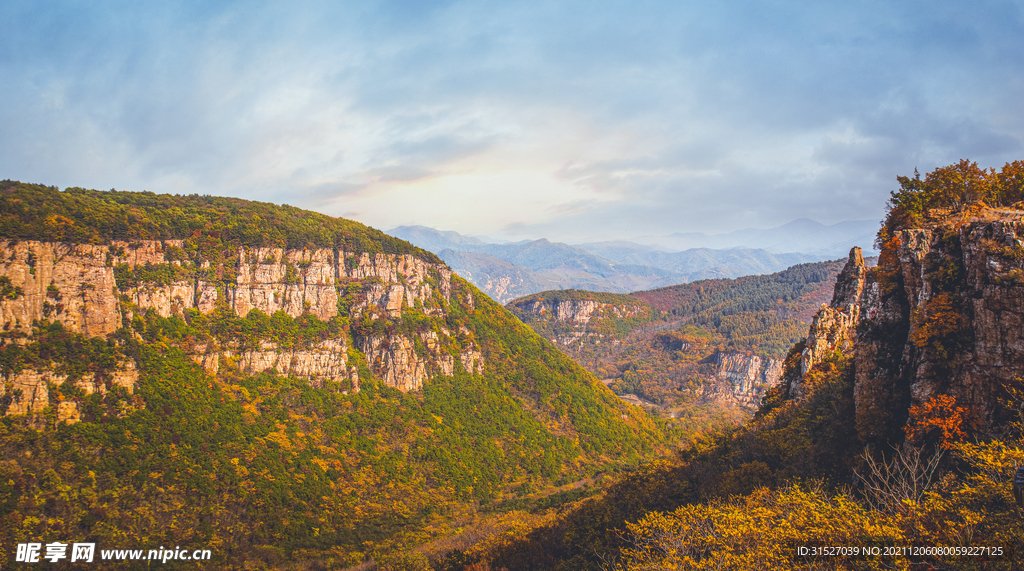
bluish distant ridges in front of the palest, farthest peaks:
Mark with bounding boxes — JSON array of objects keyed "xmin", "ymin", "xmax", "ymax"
[{"xmin": 389, "ymin": 226, "xmax": 819, "ymax": 303}]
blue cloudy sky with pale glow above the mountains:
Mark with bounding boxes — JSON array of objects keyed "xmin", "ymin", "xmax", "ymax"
[{"xmin": 0, "ymin": 0, "xmax": 1024, "ymax": 243}]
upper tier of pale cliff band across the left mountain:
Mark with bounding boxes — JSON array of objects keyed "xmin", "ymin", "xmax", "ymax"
[{"xmin": 0, "ymin": 240, "xmax": 452, "ymax": 336}]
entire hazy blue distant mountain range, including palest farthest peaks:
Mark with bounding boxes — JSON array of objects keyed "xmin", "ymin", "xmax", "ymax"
[{"xmin": 388, "ymin": 219, "xmax": 878, "ymax": 303}]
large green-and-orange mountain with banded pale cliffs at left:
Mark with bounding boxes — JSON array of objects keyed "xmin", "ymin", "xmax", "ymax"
[{"xmin": 0, "ymin": 181, "xmax": 664, "ymax": 569}]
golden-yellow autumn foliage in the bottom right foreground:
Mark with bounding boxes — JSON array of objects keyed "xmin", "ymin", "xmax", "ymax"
[{"xmin": 614, "ymin": 433, "xmax": 1024, "ymax": 571}]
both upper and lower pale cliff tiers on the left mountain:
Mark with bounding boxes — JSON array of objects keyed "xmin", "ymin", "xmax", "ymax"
[{"xmin": 0, "ymin": 240, "xmax": 483, "ymax": 414}]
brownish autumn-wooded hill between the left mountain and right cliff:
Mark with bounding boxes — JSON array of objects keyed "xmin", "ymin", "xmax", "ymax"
[{"xmin": 506, "ymin": 261, "xmax": 842, "ymax": 424}]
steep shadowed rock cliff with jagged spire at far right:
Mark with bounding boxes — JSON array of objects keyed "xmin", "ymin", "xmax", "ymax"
[{"xmin": 787, "ymin": 209, "xmax": 1024, "ymax": 439}]
